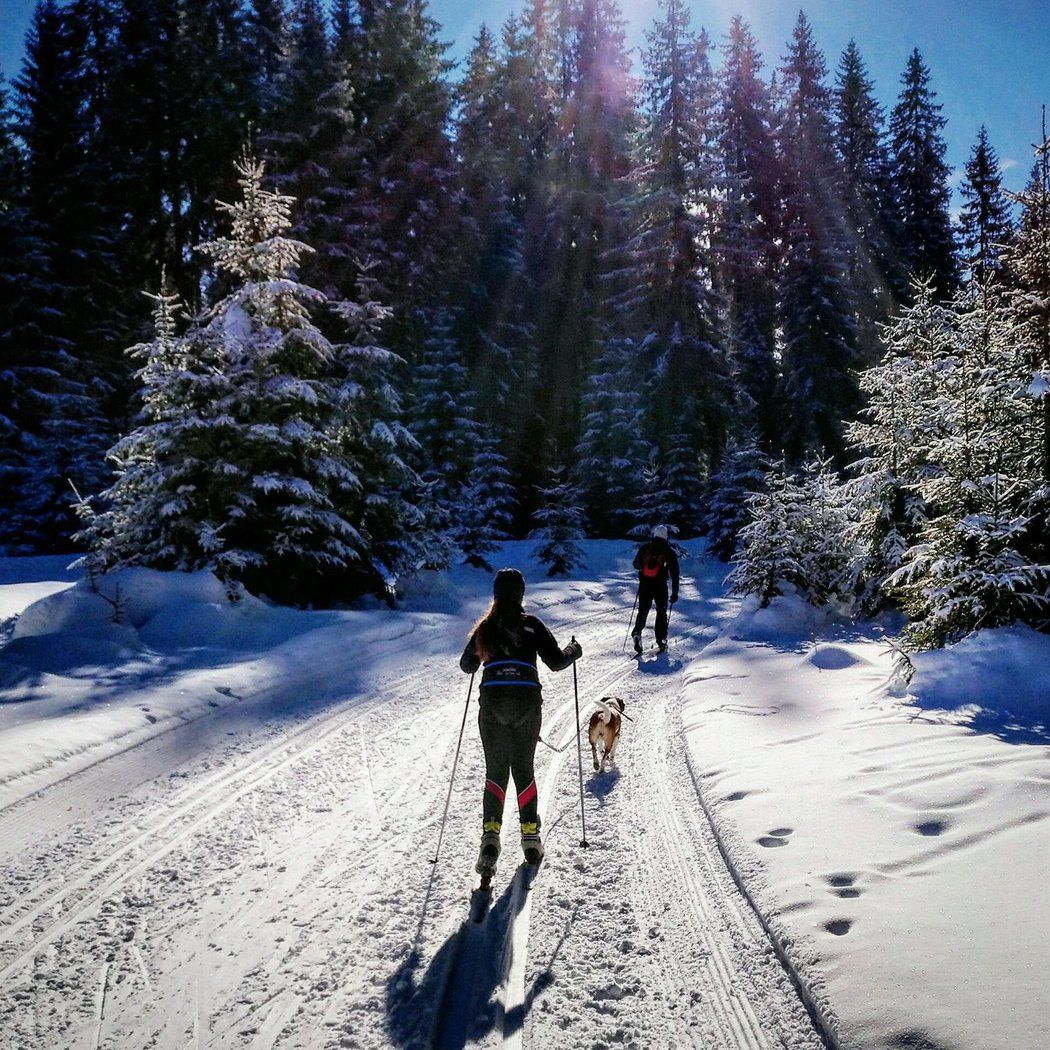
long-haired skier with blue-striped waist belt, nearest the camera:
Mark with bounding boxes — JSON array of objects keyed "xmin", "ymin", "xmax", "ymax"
[{"xmin": 460, "ymin": 569, "xmax": 583, "ymax": 877}]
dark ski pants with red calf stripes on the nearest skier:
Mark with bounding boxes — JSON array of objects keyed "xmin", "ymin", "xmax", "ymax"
[{"xmin": 478, "ymin": 686, "xmax": 543, "ymax": 835}]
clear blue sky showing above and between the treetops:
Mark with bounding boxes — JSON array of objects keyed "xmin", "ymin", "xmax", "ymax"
[{"xmin": 0, "ymin": 0, "xmax": 1050, "ymax": 198}]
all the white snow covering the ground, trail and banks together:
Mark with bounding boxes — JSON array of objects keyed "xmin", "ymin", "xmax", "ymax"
[{"xmin": 0, "ymin": 541, "xmax": 1050, "ymax": 1050}]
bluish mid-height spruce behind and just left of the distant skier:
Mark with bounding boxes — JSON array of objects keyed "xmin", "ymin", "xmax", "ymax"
[{"xmin": 575, "ymin": 339, "xmax": 650, "ymax": 536}]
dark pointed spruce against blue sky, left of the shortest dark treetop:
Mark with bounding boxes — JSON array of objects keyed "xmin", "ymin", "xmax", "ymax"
[{"xmin": 889, "ymin": 48, "xmax": 959, "ymax": 296}]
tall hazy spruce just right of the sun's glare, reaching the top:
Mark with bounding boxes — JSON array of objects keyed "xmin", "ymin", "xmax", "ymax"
[{"xmin": 608, "ymin": 0, "xmax": 731, "ymax": 458}]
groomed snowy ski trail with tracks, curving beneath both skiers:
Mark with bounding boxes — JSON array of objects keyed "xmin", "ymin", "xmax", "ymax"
[{"xmin": 0, "ymin": 566, "xmax": 820, "ymax": 1048}]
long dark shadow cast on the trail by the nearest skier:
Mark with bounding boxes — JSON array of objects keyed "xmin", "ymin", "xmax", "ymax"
[{"xmin": 386, "ymin": 873, "xmax": 549, "ymax": 1050}]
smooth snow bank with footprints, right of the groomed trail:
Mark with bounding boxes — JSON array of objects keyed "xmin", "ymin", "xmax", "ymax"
[{"xmin": 683, "ymin": 613, "xmax": 1050, "ymax": 1050}]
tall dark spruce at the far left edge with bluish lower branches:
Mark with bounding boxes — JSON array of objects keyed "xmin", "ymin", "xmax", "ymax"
[{"xmin": 0, "ymin": 0, "xmax": 116, "ymax": 550}]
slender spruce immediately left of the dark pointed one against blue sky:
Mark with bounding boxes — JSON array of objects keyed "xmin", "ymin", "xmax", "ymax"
[{"xmin": 834, "ymin": 40, "xmax": 905, "ymax": 366}]
